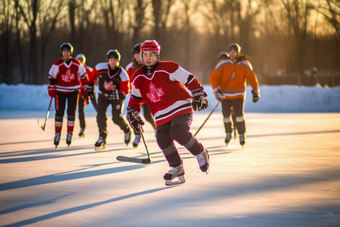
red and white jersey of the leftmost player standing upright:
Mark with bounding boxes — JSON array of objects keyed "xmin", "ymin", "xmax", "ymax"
[{"xmin": 48, "ymin": 57, "xmax": 86, "ymax": 94}]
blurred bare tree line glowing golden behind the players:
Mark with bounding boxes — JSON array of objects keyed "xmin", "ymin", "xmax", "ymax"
[{"xmin": 0, "ymin": 0, "xmax": 340, "ymax": 84}]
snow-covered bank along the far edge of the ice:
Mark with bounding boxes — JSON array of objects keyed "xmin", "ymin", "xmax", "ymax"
[{"xmin": 0, "ymin": 84, "xmax": 340, "ymax": 113}]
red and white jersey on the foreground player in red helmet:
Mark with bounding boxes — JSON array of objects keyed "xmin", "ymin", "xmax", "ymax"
[{"xmin": 129, "ymin": 61, "xmax": 202, "ymax": 126}]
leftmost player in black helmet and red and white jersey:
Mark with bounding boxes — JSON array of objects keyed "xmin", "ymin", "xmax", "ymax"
[{"xmin": 47, "ymin": 43, "xmax": 87, "ymax": 148}]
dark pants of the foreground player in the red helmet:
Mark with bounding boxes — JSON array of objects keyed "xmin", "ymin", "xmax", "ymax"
[{"xmin": 157, "ymin": 113, "xmax": 203, "ymax": 167}]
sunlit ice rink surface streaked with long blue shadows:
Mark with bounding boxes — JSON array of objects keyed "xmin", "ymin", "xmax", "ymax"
[{"xmin": 0, "ymin": 111, "xmax": 340, "ymax": 227}]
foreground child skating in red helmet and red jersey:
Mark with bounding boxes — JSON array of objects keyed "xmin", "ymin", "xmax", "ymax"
[{"xmin": 126, "ymin": 40, "xmax": 209, "ymax": 185}]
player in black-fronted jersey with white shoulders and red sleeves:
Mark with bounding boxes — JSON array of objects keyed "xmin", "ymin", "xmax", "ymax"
[{"xmin": 87, "ymin": 50, "xmax": 131, "ymax": 150}]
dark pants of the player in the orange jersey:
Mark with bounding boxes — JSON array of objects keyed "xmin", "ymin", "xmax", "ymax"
[{"xmin": 222, "ymin": 98, "xmax": 246, "ymax": 134}]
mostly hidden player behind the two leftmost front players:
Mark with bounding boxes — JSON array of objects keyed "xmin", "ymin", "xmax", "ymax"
[{"xmin": 76, "ymin": 54, "xmax": 97, "ymax": 138}]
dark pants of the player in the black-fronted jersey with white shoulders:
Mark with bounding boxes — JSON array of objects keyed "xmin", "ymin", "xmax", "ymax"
[{"xmin": 97, "ymin": 95, "xmax": 130, "ymax": 139}]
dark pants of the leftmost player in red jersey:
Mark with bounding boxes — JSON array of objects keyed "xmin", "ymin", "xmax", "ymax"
[{"xmin": 55, "ymin": 91, "xmax": 79, "ymax": 132}]
